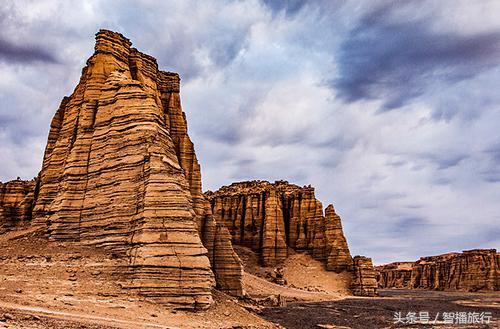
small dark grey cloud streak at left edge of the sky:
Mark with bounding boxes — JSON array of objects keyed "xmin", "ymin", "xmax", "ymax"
[{"xmin": 0, "ymin": 36, "xmax": 58, "ymax": 63}]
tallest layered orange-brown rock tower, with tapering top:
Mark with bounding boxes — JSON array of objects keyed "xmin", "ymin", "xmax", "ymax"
[{"xmin": 22, "ymin": 30, "xmax": 242, "ymax": 308}]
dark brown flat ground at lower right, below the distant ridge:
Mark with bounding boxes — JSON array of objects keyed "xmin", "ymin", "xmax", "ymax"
[{"xmin": 261, "ymin": 289, "xmax": 500, "ymax": 329}]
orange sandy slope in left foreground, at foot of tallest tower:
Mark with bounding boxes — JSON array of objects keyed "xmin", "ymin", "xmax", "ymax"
[{"xmin": 0, "ymin": 232, "xmax": 275, "ymax": 329}]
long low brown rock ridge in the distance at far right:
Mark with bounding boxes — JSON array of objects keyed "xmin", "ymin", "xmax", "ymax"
[{"xmin": 378, "ymin": 249, "xmax": 500, "ymax": 291}]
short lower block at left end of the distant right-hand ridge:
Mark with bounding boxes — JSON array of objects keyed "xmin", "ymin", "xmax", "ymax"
[{"xmin": 375, "ymin": 262, "xmax": 413, "ymax": 288}]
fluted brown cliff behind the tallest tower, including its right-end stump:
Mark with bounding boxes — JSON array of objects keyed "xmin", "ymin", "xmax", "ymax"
[{"xmin": 205, "ymin": 181, "xmax": 376, "ymax": 295}]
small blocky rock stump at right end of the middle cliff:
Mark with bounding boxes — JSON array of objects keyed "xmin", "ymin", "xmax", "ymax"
[{"xmin": 351, "ymin": 256, "xmax": 377, "ymax": 297}]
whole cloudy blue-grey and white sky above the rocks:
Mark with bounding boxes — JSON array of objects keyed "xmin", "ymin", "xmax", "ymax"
[{"xmin": 0, "ymin": 0, "xmax": 500, "ymax": 264}]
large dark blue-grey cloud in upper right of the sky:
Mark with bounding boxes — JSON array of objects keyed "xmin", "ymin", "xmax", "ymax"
[{"xmin": 330, "ymin": 2, "xmax": 500, "ymax": 110}]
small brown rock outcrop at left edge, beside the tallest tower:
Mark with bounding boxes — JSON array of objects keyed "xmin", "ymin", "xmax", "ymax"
[{"xmin": 0, "ymin": 179, "xmax": 36, "ymax": 232}]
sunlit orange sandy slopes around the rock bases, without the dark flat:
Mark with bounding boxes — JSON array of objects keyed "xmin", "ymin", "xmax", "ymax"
[{"xmin": 0, "ymin": 229, "xmax": 347, "ymax": 328}]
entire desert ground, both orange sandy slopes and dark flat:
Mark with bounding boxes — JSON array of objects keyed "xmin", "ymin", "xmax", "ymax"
[{"xmin": 0, "ymin": 230, "xmax": 500, "ymax": 329}]
